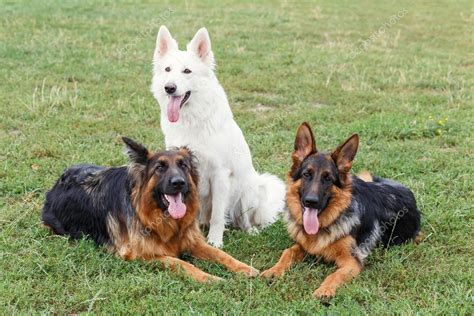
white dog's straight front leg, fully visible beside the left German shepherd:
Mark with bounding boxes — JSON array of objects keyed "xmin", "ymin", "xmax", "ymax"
[{"xmin": 207, "ymin": 170, "xmax": 230, "ymax": 248}]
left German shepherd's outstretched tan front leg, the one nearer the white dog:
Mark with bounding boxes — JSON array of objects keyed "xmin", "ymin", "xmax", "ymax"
[{"xmin": 190, "ymin": 240, "xmax": 260, "ymax": 277}]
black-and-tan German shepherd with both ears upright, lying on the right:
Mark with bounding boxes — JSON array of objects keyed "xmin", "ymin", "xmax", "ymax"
[{"xmin": 262, "ymin": 123, "xmax": 420, "ymax": 298}]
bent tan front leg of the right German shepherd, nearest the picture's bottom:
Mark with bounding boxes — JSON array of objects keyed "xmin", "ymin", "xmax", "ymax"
[{"xmin": 313, "ymin": 237, "xmax": 362, "ymax": 298}]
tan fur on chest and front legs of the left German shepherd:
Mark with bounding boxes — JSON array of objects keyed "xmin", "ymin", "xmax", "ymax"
[{"xmin": 107, "ymin": 148, "xmax": 258, "ymax": 282}]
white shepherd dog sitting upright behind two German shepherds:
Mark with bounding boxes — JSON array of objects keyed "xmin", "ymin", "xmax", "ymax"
[{"xmin": 151, "ymin": 26, "xmax": 285, "ymax": 247}]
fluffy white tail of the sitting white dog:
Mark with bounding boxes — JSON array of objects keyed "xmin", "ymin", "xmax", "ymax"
[{"xmin": 253, "ymin": 173, "xmax": 286, "ymax": 228}]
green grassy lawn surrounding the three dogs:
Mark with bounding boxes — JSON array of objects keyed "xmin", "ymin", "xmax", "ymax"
[{"xmin": 0, "ymin": 0, "xmax": 474, "ymax": 314}]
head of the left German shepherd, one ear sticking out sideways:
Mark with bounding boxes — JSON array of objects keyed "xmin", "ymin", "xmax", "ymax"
[{"xmin": 122, "ymin": 137, "xmax": 199, "ymax": 221}]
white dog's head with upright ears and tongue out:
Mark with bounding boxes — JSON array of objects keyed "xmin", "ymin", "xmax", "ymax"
[{"xmin": 151, "ymin": 25, "xmax": 215, "ymax": 123}]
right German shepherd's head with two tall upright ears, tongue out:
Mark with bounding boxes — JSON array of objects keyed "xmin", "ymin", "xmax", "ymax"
[{"xmin": 288, "ymin": 122, "xmax": 359, "ymax": 235}]
